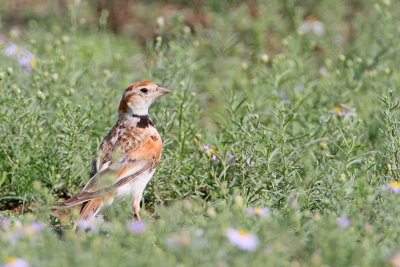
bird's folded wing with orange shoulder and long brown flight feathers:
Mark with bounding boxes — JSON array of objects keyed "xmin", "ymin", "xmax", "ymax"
[{"xmin": 58, "ymin": 131, "xmax": 162, "ymax": 207}]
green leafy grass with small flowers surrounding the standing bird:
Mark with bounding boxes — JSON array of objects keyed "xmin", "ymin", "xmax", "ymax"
[{"xmin": 0, "ymin": 0, "xmax": 400, "ymax": 266}]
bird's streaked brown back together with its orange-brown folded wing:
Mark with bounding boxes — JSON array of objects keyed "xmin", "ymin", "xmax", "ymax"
[{"xmin": 57, "ymin": 120, "xmax": 162, "ymax": 208}]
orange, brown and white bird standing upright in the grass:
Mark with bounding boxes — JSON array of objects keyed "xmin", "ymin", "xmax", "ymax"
[{"xmin": 55, "ymin": 81, "xmax": 171, "ymax": 230}]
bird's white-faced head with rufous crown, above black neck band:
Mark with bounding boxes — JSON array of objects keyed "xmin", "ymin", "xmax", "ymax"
[{"xmin": 118, "ymin": 81, "xmax": 171, "ymax": 116}]
